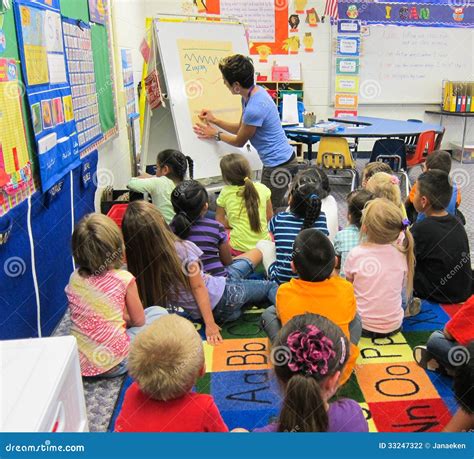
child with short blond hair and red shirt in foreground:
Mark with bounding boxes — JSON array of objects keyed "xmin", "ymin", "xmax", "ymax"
[{"xmin": 115, "ymin": 314, "xmax": 228, "ymax": 432}]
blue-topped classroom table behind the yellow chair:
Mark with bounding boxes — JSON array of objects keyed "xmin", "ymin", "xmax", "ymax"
[{"xmin": 283, "ymin": 116, "xmax": 443, "ymax": 160}]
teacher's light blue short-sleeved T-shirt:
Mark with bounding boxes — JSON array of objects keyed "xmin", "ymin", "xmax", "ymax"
[{"xmin": 242, "ymin": 89, "xmax": 293, "ymax": 167}]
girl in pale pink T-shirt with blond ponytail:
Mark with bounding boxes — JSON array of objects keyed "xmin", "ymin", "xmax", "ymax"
[{"xmin": 344, "ymin": 199, "xmax": 415, "ymax": 338}]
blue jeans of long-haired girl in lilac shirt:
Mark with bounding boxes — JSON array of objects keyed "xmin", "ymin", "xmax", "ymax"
[{"xmin": 212, "ymin": 277, "xmax": 278, "ymax": 324}]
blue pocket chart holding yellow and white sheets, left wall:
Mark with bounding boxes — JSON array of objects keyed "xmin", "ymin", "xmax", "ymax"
[{"xmin": 15, "ymin": 0, "xmax": 80, "ymax": 192}]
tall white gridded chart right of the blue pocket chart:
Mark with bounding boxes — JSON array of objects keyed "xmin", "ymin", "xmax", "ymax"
[{"xmin": 63, "ymin": 18, "xmax": 103, "ymax": 152}]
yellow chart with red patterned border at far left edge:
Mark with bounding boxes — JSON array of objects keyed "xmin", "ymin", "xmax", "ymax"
[{"xmin": 0, "ymin": 59, "xmax": 34, "ymax": 216}]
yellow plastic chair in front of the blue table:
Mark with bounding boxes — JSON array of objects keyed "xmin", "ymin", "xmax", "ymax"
[{"xmin": 316, "ymin": 137, "xmax": 359, "ymax": 191}]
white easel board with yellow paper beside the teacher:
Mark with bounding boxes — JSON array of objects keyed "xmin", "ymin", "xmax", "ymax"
[{"xmin": 151, "ymin": 20, "xmax": 262, "ymax": 179}]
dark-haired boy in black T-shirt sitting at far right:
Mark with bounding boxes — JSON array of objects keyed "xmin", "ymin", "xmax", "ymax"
[{"xmin": 412, "ymin": 169, "xmax": 472, "ymax": 304}]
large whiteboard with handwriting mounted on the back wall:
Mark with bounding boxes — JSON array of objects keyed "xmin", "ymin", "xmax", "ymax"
[{"xmin": 359, "ymin": 25, "xmax": 474, "ymax": 104}]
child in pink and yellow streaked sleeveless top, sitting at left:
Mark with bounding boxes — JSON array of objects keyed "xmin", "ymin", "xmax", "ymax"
[{"xmin": 65, "ymin": 214, "xmax": 167, "ymax": 378}]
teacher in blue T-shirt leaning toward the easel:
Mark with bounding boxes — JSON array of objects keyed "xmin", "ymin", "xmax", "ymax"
[{"xmin": 193, "ymin": 54, "xmax": 298, "ymax": 211}]
